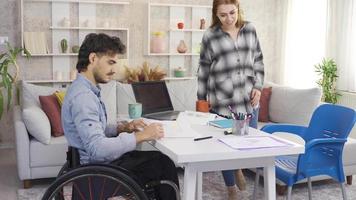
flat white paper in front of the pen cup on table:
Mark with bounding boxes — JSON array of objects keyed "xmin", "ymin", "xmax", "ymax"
[{"xmin": 219, "ymin": 136, "xmax": 293, "ymax": 150}]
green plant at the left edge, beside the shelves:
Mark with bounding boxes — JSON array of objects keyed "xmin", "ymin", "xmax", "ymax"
[{"xmin": 0, "ymin": 42, "xmax": 31, "ymax": 119}]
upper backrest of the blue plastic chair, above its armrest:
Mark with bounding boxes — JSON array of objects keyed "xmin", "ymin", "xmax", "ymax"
[{"xmin": 303, "ymin": 104, "xmax": 356, "ymax": 142}]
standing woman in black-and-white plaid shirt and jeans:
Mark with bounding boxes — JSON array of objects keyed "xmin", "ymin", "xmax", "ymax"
[{"xmin": 198, "ymin": 0, "xmax": 264, "ymax": 200}]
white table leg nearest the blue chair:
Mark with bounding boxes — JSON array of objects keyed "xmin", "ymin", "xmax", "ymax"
[{"xmin": 263, "ymin": 165, "xmax": 276, "ymax": 200}]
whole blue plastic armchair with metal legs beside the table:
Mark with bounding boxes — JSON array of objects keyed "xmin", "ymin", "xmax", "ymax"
[{"xmin": 254, "ymin": 104, "xmax": 356, "ymax": 200}]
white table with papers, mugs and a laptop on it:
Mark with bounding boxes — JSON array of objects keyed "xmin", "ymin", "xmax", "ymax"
[{"xmin": 147, "ymin": 125, "xmax": 304, "ymax": 200}]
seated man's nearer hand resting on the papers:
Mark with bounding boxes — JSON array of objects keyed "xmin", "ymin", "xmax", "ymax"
[{"xmin": 135, "ymin": 123, "xmax": 164, "ymax": 143}]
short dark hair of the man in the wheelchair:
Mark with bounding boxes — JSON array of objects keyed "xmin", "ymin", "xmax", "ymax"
[{"xmin": 77, "ymin": 33, "xmax": 126, "ymax": 72}]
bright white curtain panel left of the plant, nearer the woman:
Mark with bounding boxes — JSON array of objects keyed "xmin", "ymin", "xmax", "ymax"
[{"xmin": 281, "ymin": 0, "xmax": 328, "ymax": 88}]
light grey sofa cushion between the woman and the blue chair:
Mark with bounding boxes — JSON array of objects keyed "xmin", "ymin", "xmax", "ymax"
[{"xmin": 269, "ymin": 85, "xmax": 321, "ymax": 125}]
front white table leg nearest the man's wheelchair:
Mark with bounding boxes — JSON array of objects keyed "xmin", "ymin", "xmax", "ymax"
[{"xmin": 183, "ymin": 166, "xmax": 197, "ymax": 200}]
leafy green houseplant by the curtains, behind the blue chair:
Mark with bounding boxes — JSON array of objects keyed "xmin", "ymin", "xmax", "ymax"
[{"xmin": 314, "ymin": 58, "xmax": 341, "ymax": 104}]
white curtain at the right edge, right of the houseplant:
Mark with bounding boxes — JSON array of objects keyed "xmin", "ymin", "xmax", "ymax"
[{"xmin": 327, "ymin": 0, "xmax": 356, "ymax": 92}]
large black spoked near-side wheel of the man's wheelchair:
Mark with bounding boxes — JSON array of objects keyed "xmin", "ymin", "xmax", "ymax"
[{"xmin": 42, "ymin": 165, "xmax": 148, "ymax": 200}]
